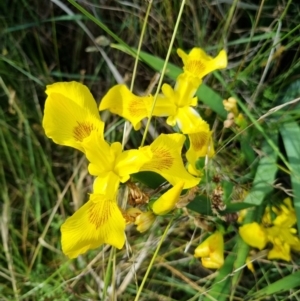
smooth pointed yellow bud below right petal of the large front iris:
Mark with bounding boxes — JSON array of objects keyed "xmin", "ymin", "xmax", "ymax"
[{"xmin": 152, "ymin": 182, "xmax": 184, "ymax": 215}]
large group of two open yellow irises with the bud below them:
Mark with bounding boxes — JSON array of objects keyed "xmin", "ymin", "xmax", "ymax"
[{"xmin": 43, "ymin": 48, "xmax": 227, "ymax": 258}]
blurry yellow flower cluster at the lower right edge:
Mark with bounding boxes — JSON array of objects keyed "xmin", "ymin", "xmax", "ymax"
[{"xmin": 239, "ymin": 198, "xmax": 300, "ymax": 261}]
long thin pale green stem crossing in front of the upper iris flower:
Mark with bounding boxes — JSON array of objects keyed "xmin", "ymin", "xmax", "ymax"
[{"xmin": 141, "ymin": 0, "xmax": 186, "ymax": 146}]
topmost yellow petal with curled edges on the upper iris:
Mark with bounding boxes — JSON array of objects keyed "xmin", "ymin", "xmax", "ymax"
[{"xmin": 177, "ymin": 47, "xmax": 227, "ymax": 79}]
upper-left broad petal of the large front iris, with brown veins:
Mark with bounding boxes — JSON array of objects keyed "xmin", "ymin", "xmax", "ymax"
[{"xmin": 43, "ymin": 82, "xmax": 104, "ymax": 152}]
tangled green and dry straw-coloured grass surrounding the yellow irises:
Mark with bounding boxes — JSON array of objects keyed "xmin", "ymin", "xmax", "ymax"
[{"xmin": 0, "ymin": 0, "xmax": 300, "ymax": 300}]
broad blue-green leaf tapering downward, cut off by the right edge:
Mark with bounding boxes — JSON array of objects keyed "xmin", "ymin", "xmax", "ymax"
[{"xmin": 280, "ymin": 121, "xmax": 300, "ymax": 233}]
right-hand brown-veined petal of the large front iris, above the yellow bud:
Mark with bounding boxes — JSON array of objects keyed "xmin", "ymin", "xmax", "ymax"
[{"xmin": 140, "ymin": 134, "xmax": 200, "ymax": 189}]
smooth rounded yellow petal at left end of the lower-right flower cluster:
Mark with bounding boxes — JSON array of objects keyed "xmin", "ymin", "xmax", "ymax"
[{"xmin": 239, "ymin": 222, "xmax": 268, "ymax": 250}]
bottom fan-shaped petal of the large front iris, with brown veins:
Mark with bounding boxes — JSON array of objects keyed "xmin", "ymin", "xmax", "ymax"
[{"xmin": 61, "ymin": 194, "xmax": 125, "ymax": 258}]
